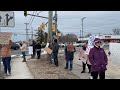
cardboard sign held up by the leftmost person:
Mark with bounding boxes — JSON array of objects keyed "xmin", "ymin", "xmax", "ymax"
[{"xmin": 0, "ymin": 32, "xmax": 12, "ymax": 44}]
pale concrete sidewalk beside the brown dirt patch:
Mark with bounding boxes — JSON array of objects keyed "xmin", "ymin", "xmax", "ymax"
[{"xmin": 5, "ymin": 57, "xmax": 34, "ymax": 79}]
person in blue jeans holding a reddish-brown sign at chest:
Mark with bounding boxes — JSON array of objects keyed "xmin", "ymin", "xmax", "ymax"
[{"xmin": 65, "ymin": 42, "xmax": 76, "ymax": 70}]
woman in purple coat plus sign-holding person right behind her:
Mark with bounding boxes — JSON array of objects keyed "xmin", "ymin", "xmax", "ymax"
[{"xmin": 80, "ymin": 38, "xmax": 108, "ymax": 79}]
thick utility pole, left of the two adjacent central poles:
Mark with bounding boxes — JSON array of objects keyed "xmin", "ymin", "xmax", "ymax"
[{"xmin": 48, "ymin": 11, "xmax": 53, "ymax": 42}]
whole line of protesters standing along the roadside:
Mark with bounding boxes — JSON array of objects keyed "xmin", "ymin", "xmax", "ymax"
[{"xmin": 0, "ymin": 38, "xmax": 108, "ymax": 79}]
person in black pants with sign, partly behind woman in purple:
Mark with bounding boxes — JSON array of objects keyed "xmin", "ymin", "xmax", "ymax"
[{"xmin": 79, "ymin": 42, "xmax": 91, "ymax": 73}]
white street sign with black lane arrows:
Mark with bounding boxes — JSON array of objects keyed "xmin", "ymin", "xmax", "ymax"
[{"xmin": 0, "ymin": 11, "xmax": 15, "ymax": 27}]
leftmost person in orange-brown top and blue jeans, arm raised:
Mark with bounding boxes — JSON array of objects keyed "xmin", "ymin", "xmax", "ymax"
[{"xmin": 1, "ymin": 40, "xmax": 12, "ymax": 77}]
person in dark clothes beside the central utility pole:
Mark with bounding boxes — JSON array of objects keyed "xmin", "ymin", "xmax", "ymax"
[{"xmin": 53, "ymin": 39, "xmax": 59, "ymax": 66}]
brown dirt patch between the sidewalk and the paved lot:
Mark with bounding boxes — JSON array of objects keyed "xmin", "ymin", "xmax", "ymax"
[{"xmin": 27, "ymin": 54, "xmax": 79, "ymax": 79}]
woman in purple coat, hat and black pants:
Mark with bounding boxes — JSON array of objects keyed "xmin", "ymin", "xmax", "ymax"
[{"xmin": 89, "ymin": 38, "xmax": 108, "ymax": 79}]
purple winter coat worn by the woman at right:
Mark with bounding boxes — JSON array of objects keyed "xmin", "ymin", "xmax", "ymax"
[{"xmin": 89, "ymin": 47, "xmax": 108, "ymax": 72}]
